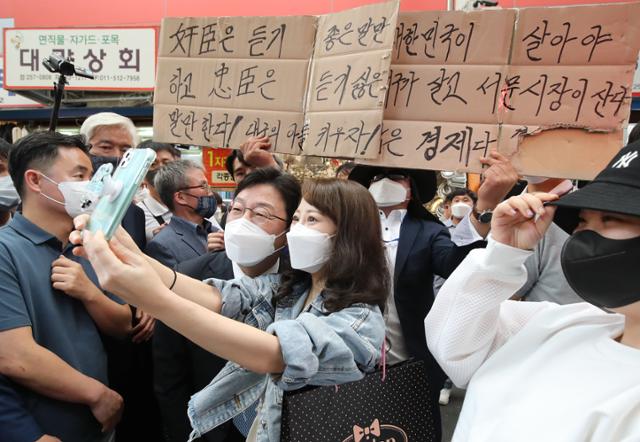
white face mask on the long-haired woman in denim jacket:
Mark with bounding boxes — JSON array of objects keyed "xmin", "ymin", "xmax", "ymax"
[{"xmin": 287, "ymin": 223, "xmax": 333, "ymax": 273}]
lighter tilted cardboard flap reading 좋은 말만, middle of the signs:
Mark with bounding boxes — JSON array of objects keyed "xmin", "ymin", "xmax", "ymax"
[{"xmin": 302, "ymin": 2, "xmax": 398, "ymax": 158}]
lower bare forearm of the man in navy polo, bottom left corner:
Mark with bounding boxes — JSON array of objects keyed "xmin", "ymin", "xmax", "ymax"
[{"xmin": 0, "ymin": 327, "xmax": 123, "ymax": 431}]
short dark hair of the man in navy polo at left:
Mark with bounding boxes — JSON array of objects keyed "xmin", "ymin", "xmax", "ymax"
[{"xmin": 9, "ymin": 132, "xmax": 89, "ymax": 197}]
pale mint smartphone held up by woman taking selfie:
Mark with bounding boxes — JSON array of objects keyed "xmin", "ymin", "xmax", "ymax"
[{"xmin": 87, "ymin": 149, "xmax": 156, "ymax": 240}]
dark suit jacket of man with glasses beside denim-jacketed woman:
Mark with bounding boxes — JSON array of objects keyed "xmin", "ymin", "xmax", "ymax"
[{"xmin": 153, "ymin": 251, "xmax": 290, "ymax": 442}]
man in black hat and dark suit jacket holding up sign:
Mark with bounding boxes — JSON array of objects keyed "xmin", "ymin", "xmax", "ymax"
[{"xmin": 349, "ymin": 154, "xmax": 517, "ymax": 439}]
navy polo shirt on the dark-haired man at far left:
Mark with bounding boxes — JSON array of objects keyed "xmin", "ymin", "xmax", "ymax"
[{"xmin": 0, "ymin": 214, "xmax": 114, "ymax": 441}]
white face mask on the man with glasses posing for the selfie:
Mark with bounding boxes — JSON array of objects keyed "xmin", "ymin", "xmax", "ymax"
[{"xmin": 224, "ymin": 218, "xmax": 284, "ymax": 267}]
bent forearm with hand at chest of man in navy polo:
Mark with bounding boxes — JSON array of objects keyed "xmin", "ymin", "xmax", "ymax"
[{"xmin": 51, "ymin": 256, "xmax": 131, "ymax": 338}]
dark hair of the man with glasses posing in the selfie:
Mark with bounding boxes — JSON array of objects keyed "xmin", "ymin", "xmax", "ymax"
[{"xmin": 235, "ymin": 167, "xmax": 302, "ymax": 225}]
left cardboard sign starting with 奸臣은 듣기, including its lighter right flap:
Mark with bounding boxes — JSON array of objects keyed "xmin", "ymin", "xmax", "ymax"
[{"xmin": 154, "ymin": 2, "xmax": 398, "ymax": 158}]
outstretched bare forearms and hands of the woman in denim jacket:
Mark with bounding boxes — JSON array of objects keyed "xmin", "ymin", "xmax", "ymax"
[{"xmin": 74, "ymin": 231, "xmax": 284, "ymax": 373}]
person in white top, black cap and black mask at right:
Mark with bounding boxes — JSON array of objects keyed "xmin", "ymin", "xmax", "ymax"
[{"xmin": 425, "ymin": 143, "xmax": 640, "ymax": 442}]
